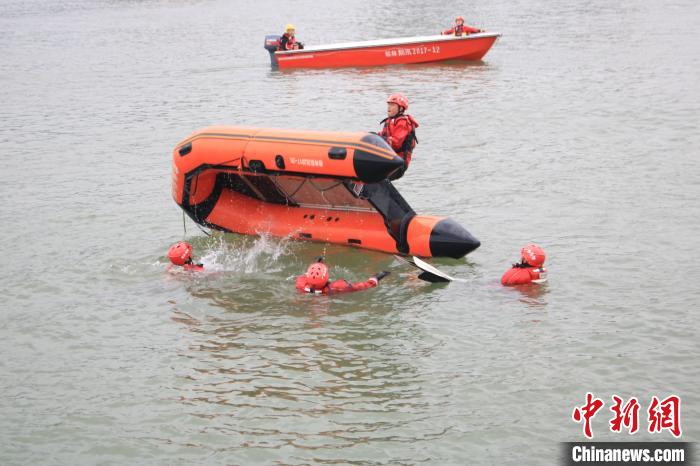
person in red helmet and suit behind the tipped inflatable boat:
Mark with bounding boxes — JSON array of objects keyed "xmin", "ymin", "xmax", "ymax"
[{"xmin": 379, "ymin": 93, "xmax": 418, "ymax": 179}]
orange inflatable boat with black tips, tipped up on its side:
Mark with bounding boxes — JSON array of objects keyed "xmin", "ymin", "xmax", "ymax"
[{"xmin": 172, "ymin": 126, "xmax": 480, "ymax": 258}]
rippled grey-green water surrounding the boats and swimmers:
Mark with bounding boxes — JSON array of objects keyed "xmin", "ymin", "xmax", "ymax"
[{"xmin": 0, "ymin": 0, "xmax": 700, "ymax": 465}]
